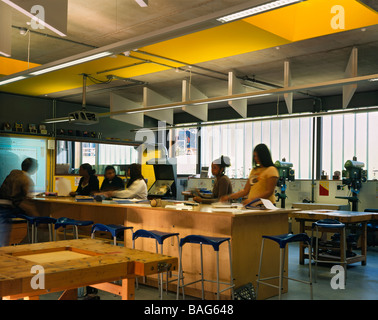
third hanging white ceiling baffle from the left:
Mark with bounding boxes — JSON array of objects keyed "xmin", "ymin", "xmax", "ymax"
[{"xmin": 182, "ymin": 80, "xmax": 209, "ymax": 121}]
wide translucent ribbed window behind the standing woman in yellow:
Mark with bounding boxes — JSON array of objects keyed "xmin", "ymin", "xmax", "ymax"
[{"xmin": 201, "ymin": 118, "xmax": 312, "ymax": 179}]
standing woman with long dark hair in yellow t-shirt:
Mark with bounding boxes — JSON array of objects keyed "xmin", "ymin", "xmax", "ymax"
[{"xmin": 221, "ymin": 144, "xmax": 279, "ymax": 204}]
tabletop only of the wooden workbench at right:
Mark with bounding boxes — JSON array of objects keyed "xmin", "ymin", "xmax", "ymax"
[{"xmin": 289, "ymin": 210, "xmax": 378, "ymax": 223}]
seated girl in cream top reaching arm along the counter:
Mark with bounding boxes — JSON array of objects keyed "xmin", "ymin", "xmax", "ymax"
[{"xmin": 100, "ymin": 163, "xmax": 148, "ymax": 200}]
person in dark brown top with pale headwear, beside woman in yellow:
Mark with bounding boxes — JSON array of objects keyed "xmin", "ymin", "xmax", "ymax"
[{"xmin": 193, "ymin": 156, "xmax": 232, "ymax": 204}]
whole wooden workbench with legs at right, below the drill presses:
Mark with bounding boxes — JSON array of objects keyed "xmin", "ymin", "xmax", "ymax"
[{"xmin": 289, "ymin": 210, "xmax": 378, "ymax": 265}]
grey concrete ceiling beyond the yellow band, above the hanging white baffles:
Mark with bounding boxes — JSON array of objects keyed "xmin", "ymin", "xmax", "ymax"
[{"xmin": 53, "ymin": 26, "xmax": 378, "ymax": 108}]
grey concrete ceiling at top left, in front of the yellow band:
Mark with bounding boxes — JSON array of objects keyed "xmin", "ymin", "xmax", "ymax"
[{"xmin": 12, "ymin": 0, "xmax": 255, "ymax": 64}]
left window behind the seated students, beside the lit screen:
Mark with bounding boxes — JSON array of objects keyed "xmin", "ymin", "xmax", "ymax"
[{"xmin": 55, "ymin": 140, "xmax": 139, "ymax": 175}]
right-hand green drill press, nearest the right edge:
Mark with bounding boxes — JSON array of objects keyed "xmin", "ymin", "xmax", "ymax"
[{"xmin": 336, "ymin": 157, "xmax": 367, "ymax": 211}]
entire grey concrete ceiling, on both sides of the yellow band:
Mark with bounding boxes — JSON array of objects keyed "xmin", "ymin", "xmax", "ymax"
[{"xmin": 2, "ymin": 0, "xmax": 378, "ymax": 121}]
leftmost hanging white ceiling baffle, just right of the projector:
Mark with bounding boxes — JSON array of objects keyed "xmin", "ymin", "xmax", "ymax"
[{"xmin": 110, "ymin": 92, "xmax": 144, "ymax": 127}]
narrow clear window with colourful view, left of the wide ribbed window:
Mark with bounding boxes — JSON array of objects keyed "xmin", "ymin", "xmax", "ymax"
[{"xmin": 169, "ymin": 128, "xmax": 198, "ymax": 175}]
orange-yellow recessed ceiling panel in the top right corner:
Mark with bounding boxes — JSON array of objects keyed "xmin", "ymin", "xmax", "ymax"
[{"xmin": 244, "ymin": 0, "xmax": 378, "ymax": 42}]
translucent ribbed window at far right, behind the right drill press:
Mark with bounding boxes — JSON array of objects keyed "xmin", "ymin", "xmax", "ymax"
[{"xmin": 322, "ymin": 112, "xmax": 378, "ymax": 180}]
